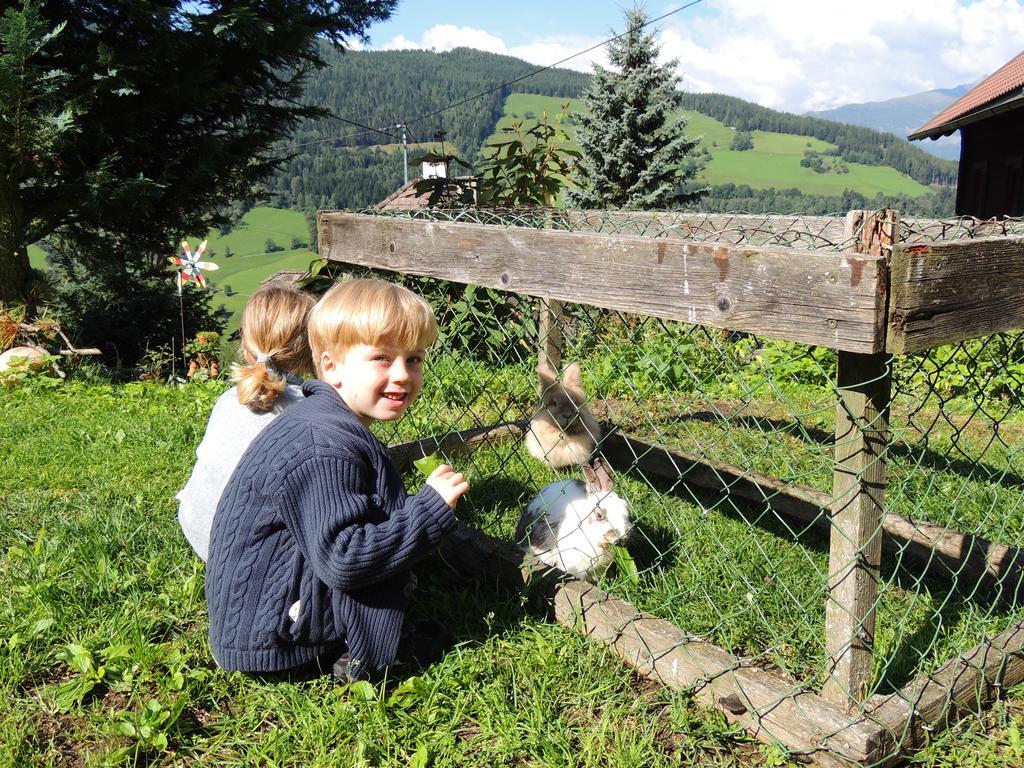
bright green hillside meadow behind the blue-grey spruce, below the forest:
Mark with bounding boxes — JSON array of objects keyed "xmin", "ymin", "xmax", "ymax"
[{"xmin": 486, "ymin": 93, "xmax": 929, "ymax": 198}]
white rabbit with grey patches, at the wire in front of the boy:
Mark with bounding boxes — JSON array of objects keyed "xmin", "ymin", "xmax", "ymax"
[{"xmin": 516, "ymin": 459, "xmax": 631, "ymax": 581}]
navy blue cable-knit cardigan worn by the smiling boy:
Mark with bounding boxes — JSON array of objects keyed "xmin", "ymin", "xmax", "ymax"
[{"xmin": 206, "ymin": 381, "xmax": 456, "ymax": 673}]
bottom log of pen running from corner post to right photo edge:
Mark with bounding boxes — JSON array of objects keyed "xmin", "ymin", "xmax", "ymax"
[{"xmin": 867, "ymin": 622, "xmax": 1024, "ymax": 754}]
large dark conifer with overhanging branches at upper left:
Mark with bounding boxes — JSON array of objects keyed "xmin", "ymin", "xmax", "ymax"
[{"xmin": 0, "ymin": 0, "xmax": 397, "ymax": 301}]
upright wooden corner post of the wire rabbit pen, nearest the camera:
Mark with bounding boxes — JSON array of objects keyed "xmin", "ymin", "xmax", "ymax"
[{"xmin": 821, "ymin": 211, "xmax": 899, "ymax": 708}]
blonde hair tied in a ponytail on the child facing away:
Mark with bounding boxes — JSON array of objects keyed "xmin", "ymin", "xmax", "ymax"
[{"xmin": 231, "ymin": 286, "xmax": 315, "ymax": 412}]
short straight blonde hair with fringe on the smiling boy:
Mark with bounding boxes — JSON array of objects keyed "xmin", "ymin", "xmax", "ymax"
[{"xmin": 309, "ymin": 278, "xmax": 437, "ymax": 373}]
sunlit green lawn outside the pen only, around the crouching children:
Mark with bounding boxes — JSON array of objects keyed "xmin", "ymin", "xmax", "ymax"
[{"xmin": 0, "ymin": 384, "xmax": 790, "ymax": 768}]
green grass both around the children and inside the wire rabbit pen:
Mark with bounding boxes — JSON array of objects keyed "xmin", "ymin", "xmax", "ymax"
[{"xmin": 6, "ymin": 321, "xmax": 1024, "ymax": 768}]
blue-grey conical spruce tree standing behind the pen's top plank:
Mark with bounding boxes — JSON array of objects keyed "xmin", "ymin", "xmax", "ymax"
[{"xmin": 566, "ymin": 8, "xmax": 703, "ymax": 210}]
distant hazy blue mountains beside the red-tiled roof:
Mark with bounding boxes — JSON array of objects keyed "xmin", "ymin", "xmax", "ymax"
[{"xmin": 807, "ymin": 83, "xmax": 976, "ymax": 160}]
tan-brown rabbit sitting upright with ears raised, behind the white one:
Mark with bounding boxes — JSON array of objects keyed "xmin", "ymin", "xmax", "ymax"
[{"xmin": 524, "ymin": 362, "xmax": 601, "ymax": 469}]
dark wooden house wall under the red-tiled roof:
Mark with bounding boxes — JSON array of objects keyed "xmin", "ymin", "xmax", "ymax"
[{"xmin": 956, "ymin": 108, "xmax": 1024, "ymax": 219}]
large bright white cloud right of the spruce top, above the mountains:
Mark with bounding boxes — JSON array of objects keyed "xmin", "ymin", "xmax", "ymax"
[{"xmin": 660, "ymin": 0, "xmax": 1024, "ymax": 113}]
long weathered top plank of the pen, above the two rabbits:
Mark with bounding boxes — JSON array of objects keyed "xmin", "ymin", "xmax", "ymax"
[{"xmin": 319, "ymin": 212, "xmax": 888, "ymax": 352}]
